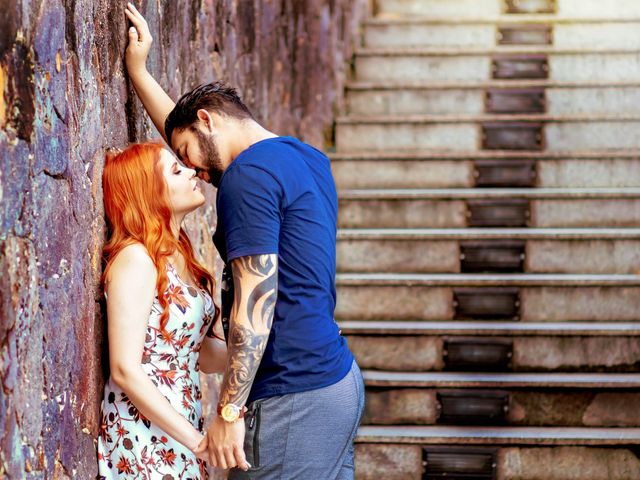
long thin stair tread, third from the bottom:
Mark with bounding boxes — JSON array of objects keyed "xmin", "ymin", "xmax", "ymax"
[{"xmin": 338, "ymin": 320, "xmax": 640, "ymax": 336}]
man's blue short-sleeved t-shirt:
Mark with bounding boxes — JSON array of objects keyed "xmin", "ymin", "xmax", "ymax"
[{"xmin": 214, "ymin": 137, "xmax": 353, "ymax": 401}]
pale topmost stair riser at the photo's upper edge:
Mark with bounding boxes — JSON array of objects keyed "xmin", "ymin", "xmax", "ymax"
[{"xmin": 376, "ymin": 0, "xmax": 640, "ymax": 19}]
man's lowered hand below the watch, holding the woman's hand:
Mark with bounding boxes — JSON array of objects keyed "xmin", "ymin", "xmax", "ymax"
[{"xmin": 195, "ymin": 415, "xmax": 251, "ymax": 471}]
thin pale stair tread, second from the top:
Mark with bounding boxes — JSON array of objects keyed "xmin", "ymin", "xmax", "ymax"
[{"xmin": 355, "ymin": 45, "xmax": 638, "ymax": 57}]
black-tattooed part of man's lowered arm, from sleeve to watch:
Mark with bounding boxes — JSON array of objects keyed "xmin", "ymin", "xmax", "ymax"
[{"xmin": 220, "ymin": 255, "xmax": 278, "ymax": 405}]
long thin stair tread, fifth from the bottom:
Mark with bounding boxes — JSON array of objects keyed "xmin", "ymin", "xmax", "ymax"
[{"xmin": 337, "ymin": 227, "xmax": 640, "ymax": 240}]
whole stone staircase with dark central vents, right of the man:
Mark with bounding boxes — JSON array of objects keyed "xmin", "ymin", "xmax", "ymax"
[{"xmin": 332, "ymin": 0, "xmax": 640, "ymax": 480}]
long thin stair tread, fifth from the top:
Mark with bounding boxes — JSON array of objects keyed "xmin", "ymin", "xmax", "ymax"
[{"xmin": 329, "ymin": 150, "xmax": 640, "ymax": 162}]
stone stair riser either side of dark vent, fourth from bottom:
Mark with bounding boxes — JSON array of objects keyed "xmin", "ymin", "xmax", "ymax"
[{"xmin": 335, "ymin": 285, "xmax": 640, "ymax": 322}]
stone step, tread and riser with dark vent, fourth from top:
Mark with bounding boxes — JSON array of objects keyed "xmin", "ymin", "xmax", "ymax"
[{"xmin": 336, "ymin": 113, "xmax": 640, "ymax": 152}]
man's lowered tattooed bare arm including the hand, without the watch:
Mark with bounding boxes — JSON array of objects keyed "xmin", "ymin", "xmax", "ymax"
[{"xmin": 199, "ymin": 254, "xmax": 278, "ymax": 469}]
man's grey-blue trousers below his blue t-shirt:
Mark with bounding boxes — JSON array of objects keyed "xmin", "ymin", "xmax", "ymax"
[{"xmin": 228, "ymin": 361, "xmax": 364, "ymax": 480}]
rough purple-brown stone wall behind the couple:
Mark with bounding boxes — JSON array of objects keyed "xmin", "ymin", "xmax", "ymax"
[{"xmin": 0, "ymin": 0, "xmax": 366, "ymax": 479}]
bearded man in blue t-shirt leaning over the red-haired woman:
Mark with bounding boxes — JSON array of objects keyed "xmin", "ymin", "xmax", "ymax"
[{"xmin": 126, "ymin": 4, "xmax": 364, "ymax": 480}]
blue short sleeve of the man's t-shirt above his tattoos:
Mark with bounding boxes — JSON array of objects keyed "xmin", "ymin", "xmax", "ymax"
[{"xmin": 217, "ymin": 165, "xmax": 284, "ymax": 262}]
